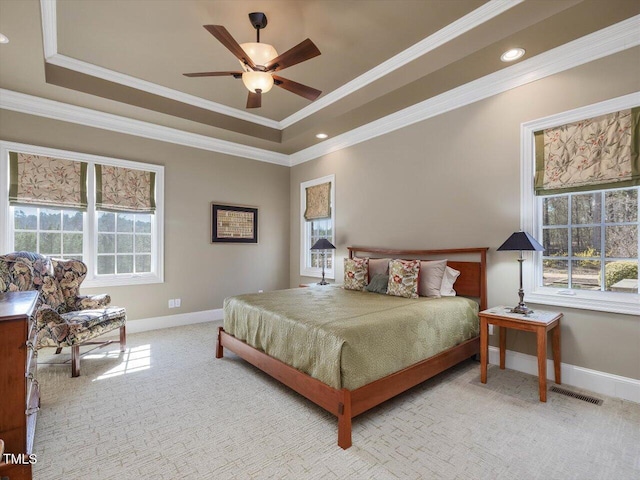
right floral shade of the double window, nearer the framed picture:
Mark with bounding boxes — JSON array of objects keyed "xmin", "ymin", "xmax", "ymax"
[{"xmin": 96, "ymin": 165, "xmax": 156, "ymax": 212}]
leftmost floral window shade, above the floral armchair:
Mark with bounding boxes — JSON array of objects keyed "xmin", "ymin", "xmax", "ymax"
[{"xmin": 9, "ymin": 152, "xmax": 87, "ymax": 210}]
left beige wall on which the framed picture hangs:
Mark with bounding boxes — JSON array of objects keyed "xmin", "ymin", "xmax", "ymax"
[{"xmin": 0, "ymin": 110, "xmax": 290, "ymax": 320}]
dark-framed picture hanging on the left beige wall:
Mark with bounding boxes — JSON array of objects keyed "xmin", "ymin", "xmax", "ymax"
[{"xmin": 211, "ymin": 203, "xmax": 258, "ymax": 243}]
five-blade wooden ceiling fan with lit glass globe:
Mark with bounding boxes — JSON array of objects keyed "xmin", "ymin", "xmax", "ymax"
[{"xmin": 183, "ymin": 12, "xmax": 322, "ymax": 108}]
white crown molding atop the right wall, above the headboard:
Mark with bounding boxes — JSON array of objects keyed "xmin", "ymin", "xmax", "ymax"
[{"xmin": 290, "ymin": 15, "xmax": 640, "ymax": 166}]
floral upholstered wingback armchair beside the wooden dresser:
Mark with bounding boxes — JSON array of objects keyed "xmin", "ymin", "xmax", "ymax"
[{"xmin": 0, "ymin": 252, "xmax": 127, "ymax": 377}]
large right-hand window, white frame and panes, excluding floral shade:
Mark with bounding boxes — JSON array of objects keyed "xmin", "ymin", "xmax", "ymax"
[{"xmin": 521, "ymin": 96, "xmax": 640, "ymax": 315}]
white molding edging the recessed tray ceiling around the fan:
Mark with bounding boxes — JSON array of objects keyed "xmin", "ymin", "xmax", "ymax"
[{"xmin": 40, "ymin": 0, "xmax": 524, "ymax": 130}]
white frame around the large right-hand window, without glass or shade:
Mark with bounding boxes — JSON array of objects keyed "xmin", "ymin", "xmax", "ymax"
[{"xmin": 520, "ymin": 92, "xmax": 640, "ymax": 315}]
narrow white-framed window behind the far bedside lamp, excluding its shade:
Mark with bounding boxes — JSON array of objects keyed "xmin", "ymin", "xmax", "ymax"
[{"xmin": 300, "ymin": 175, "xmax": 335, "ymax": 279}]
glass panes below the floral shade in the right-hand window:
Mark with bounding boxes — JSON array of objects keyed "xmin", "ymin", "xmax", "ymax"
[{"xmin": 537, "ymin": 187, "xmax": 639, "ymax": 294}]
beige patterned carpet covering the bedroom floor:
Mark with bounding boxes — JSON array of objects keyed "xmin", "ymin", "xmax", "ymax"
[{"xmin": 34, "ymin": 323, "xmax": 640, "ymax": 480}]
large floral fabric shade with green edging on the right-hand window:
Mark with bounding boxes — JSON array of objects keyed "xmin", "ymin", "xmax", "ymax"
[{"xmin": 535, "ymin": 107, "xmax": 640, "ymax": 195}]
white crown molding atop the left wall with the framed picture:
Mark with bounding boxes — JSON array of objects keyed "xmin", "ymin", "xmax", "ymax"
[{"xmin": 0, "ymin": 89, "xmax": 289, "ymax": 166}]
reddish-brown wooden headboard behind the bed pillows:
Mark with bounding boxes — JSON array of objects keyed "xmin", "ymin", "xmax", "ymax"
[{"xmin": 347, "ymin": 247, "xmax": 489, "ymax": 310}]
